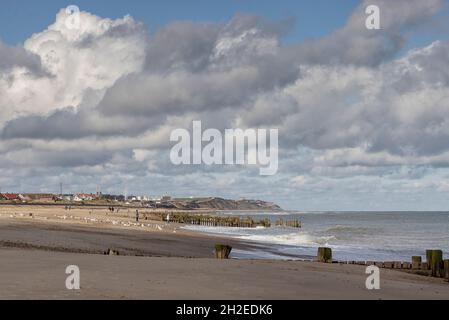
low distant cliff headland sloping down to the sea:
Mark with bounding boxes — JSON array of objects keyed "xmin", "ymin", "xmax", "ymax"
[{"xmin": 171, "ymin": 198, "xmax": 282, "ymax": 211}]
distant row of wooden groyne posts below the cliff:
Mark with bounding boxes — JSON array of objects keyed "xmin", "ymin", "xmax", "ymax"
[{"xmin": 148, "ymin": 213, "xmax": 301, "ymax": 228}]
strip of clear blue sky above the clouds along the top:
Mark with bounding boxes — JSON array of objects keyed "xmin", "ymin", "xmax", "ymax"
[{"xmin": 0, "ymin": 0, "xmax": 374, "ymax": 45}]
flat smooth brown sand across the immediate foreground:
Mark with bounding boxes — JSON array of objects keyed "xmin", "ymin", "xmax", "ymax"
[{"xmin": 0, "ymin": 249, "xmax": 449, "ymax": 300}]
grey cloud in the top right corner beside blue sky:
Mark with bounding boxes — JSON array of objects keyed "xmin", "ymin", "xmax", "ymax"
[{"xmin": 299, "ymin": 0, "xmax": 444, "ymax": 66}]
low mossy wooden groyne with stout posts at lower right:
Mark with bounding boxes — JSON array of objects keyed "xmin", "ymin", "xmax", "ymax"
[{"xmin": 316, "ymin": 248, "xmax": 449, "ymax": 281}]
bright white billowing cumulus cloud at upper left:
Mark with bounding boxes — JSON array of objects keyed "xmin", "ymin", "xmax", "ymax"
[{"xmin": 0, "ymin": 10, "xmax": 146, "ymax": 124}]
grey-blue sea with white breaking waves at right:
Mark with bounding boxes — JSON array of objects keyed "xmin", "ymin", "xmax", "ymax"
[{"xmin": 181, "ymin": 211, "xmax": 449, "ymax": 261}]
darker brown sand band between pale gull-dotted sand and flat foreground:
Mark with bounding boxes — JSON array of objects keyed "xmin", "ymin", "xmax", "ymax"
[{"xmin": 0, "ymin": 221, "xmax": 244, "ymax": 258}]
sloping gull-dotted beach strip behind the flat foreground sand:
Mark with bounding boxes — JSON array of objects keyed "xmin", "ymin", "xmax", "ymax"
[{"xmin": 0, "ymin": 206, "xmax": 290, "ymax": 258}]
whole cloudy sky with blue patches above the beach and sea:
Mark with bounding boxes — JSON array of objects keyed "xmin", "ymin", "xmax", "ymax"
[{"xmin": 0, "ymin": 0, "xmax": 449, "ymax": 210}]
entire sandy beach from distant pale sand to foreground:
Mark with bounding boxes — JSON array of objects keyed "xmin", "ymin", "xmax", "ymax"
[{"xmin": 0, "ymin": 206, "xmax": 449, "ymax": 300}]
